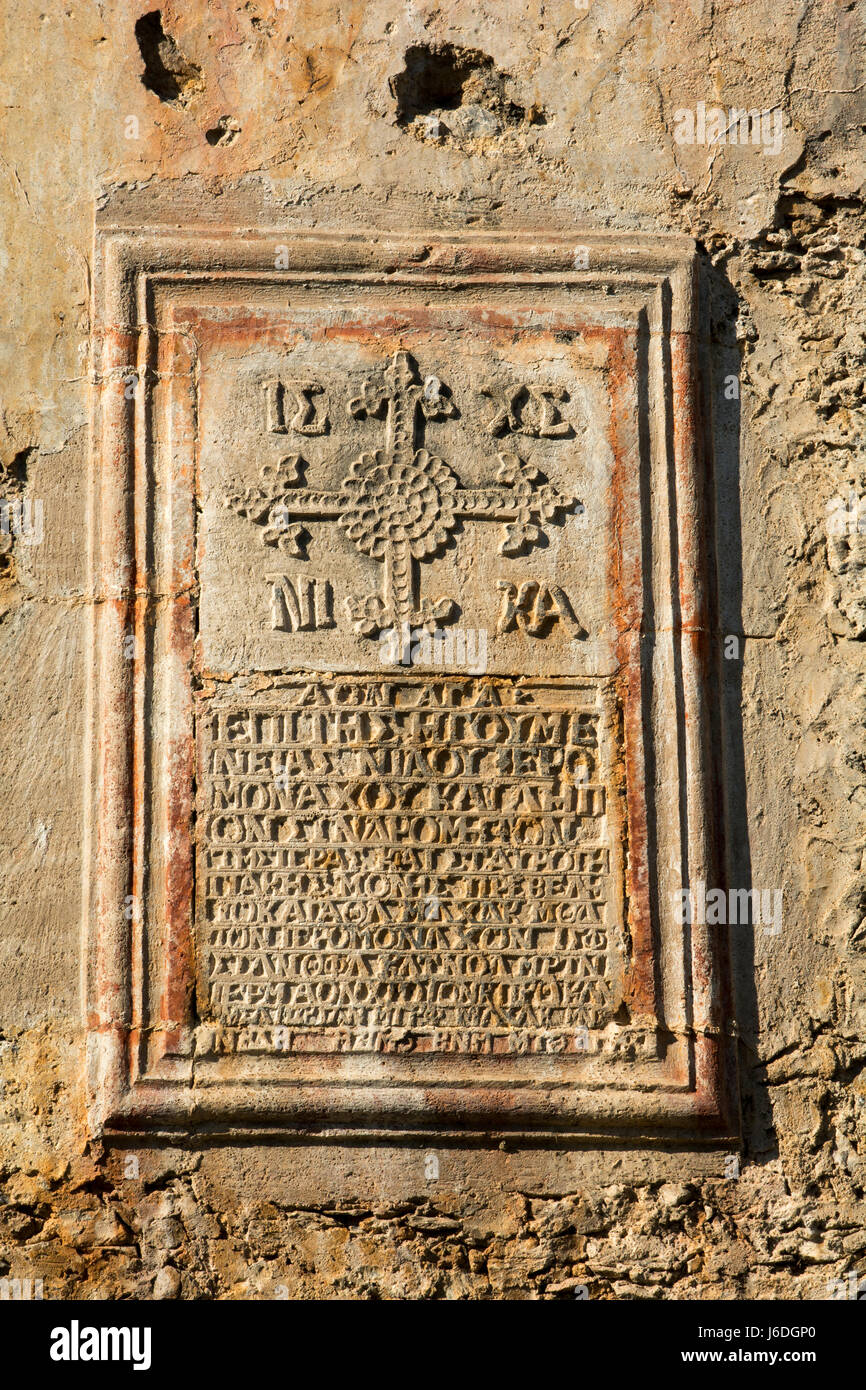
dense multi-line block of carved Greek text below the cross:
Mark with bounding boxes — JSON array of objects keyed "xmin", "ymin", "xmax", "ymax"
[{"xmin": 199, "ymin": 675, "xmax": 612, "ymax": 1054}]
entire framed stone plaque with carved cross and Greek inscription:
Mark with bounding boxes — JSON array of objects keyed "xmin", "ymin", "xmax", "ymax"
[{"xmin": 86, "ymin": 227, "xmax": 731, "ymax": 1143}]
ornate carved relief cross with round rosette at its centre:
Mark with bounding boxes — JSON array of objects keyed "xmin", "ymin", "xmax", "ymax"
[{"xmin": 225, "ymin": 352, "xmax": 575, "ymax": 637}]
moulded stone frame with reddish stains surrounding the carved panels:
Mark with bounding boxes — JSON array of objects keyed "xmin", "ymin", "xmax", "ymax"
[{"xmin": 83, "ymin": 227, "xmax": 737, "ymax": 1144}]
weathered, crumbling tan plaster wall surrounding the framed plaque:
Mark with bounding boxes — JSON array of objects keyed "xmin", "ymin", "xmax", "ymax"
[{"xmin": 0, "ymin": 0, "xmax": 866, "ymax": 1298}]
